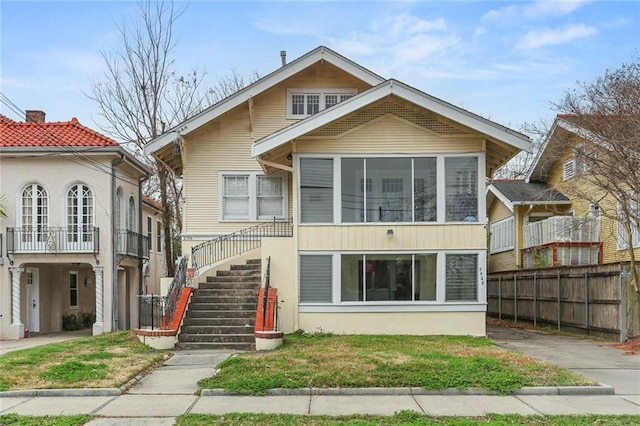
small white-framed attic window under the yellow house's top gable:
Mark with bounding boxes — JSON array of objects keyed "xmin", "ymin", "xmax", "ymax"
[{"xmin": 287, "ymin": 88, "xmax": 357, "ymax": 118}]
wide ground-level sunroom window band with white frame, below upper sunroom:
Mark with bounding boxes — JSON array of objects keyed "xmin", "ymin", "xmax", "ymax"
[{"xmin": 299, "ymin": 252, "xmax": 480, "ymax": 305}]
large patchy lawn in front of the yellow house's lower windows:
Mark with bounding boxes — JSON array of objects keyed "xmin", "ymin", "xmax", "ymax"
[{"xmin": 199, "ymin": 333, "xmax": 597, "ymax": 395}]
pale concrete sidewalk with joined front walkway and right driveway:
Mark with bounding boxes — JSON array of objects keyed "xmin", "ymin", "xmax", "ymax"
[{"xmin": 0, "ymin": 326, "xmax": 640, "ymax": 426}]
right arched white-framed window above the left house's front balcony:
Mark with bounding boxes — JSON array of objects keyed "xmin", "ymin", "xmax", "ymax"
[{"xmin": 67, "ymin": 183, "xmax": 94, "ymax": 243}]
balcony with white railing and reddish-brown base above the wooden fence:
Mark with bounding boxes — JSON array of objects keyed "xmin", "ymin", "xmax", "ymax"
[{"xmin": 522, "ymin": 216, "xmax": 602, "ymax": 268}]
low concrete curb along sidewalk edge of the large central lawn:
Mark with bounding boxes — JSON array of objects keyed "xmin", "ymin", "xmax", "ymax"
[{"xmin": 200, "ymin": 385, "xmax": 615, "ymax": 397}]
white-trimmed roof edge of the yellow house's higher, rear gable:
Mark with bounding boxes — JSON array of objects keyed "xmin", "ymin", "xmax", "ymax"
[{"xmin": 144, "ymin": 46, "xmax": 384, "ymax": 154}]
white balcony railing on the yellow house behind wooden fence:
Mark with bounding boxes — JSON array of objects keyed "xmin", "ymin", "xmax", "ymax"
[{"xmin": 523, "ymin": 216, "xmax": 600, "ymax": 248}]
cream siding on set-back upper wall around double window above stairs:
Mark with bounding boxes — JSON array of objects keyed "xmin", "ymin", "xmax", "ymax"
[{"xmin": 183, "ymin": 62, "xmax": 370, "ymax": 235}]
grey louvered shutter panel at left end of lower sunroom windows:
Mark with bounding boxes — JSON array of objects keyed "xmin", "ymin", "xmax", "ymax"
[{"xmin": 300, "ymin": 255, "xmax": 333, "ymax": 303}]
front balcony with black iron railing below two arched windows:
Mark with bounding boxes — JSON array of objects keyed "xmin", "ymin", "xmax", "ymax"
[{"xmin": 7, "ymin": 226, "xmax": 100, "ymax": 254}]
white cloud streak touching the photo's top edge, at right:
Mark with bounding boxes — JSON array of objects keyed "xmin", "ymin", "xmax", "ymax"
[{"xmin": 482, "ymin": 0, "xmax": 589, "ymax": 23}]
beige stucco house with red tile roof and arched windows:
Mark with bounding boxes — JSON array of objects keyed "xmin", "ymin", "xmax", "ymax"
[{"xmin": 0, "ymin": 111, "xmax": 161, "ymax": 339}]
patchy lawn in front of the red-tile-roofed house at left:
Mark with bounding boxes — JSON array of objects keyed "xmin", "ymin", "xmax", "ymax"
[{"xmin": 0, "ymin": 331, "xmax": 167, "ymax": 391}]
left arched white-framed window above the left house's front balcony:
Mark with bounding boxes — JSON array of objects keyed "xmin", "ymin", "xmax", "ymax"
[{"xmin": 21, "ymin": 183, "xmax": 49, "ymax": 243}]
